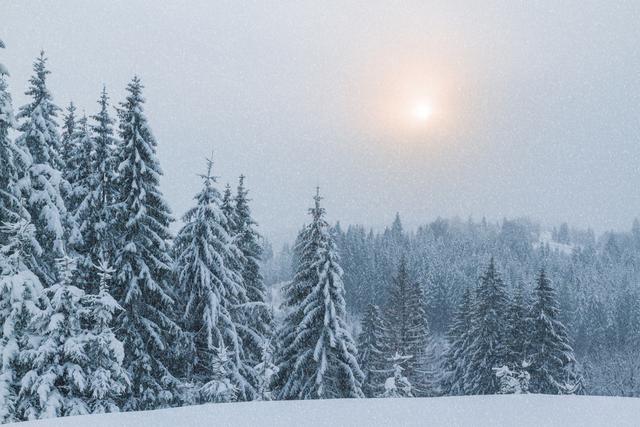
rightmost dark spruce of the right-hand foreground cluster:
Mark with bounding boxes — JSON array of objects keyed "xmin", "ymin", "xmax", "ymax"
[{"xmin": 528, "ymin": 270, "xmax": 582, "ymax": 394}]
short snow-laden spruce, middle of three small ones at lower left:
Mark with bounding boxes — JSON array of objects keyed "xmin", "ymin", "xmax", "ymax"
[{"xmin": 19, "ymin": 256, "xmax": 90, "ymax": 420}]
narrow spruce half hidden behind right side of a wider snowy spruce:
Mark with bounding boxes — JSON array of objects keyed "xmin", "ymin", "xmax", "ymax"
[{"xmin": 234, "ymin": 175, "xmax": 274, "ymax": 372}]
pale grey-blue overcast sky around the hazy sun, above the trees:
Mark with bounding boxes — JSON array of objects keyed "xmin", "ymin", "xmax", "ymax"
[{"xmin": 0, "ymin": 0, "xmax": 640, "ymax": 246}]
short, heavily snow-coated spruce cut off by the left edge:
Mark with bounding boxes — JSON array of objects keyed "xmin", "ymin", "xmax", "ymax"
[{"xmin": 0, "ymin": 220, "xmax": 48, "ymax": 423}]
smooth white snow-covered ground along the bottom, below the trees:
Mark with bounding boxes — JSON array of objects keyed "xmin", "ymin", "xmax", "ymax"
[{"xmin": 8, "ymin": 395, "xmax": 640, "ymax": 427}]
